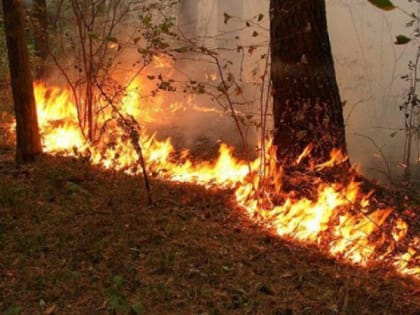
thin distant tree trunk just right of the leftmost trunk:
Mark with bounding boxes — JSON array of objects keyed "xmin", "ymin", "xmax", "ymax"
[{"xmin": 32, "ymin": 0, "xmax": 49, "ymax": 79}]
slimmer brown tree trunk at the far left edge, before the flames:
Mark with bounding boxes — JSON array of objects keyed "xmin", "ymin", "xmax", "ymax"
[{"xmin": 3, "ymin": 0, "xmax": 42, "ymax": 163}]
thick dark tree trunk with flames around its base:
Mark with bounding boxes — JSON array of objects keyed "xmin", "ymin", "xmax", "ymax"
[{"xmin": 270, "ymin": 0, "xmax": 346, "ymax": 165}]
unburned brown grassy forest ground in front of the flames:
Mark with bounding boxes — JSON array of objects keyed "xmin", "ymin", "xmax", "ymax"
[{"xmin": 0, "ymin": 148, "xmax": 420, "ymax": 315}]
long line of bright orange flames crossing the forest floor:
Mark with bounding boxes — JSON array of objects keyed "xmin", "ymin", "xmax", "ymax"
[{"xmin": 2, "ymin": 81, "xmax": 420, "ymax": 277}]
